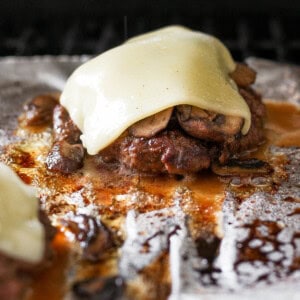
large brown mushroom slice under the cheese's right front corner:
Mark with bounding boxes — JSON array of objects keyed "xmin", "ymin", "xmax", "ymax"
[{"xmin": 176, "ymin": 105, "xmax": 244, "ymax": 142}]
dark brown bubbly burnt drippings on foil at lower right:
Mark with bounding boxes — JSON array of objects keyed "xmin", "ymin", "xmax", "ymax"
[{"xmin": 234, "ymin": 219, "xmax": 299, "ymax": 286}]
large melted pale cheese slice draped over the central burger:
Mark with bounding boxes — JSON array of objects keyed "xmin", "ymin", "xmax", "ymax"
[{"xmin": 60, "ymin": 26, "xmax": 251, "ymax": 155}]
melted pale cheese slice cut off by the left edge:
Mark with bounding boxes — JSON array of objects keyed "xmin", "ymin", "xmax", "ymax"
[{"xmin": 0, "ymin": 163, "xmax": 45, "ymax": 263}]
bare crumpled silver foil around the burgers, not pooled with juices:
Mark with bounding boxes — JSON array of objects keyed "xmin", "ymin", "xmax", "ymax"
[{"xmin": 0, "ymin": 56, "xmax": 300, "ymax": 300}]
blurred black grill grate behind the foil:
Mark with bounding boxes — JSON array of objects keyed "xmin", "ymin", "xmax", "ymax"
[{"xmin": 0, "ymin": 15, "xmax": 300, "ymax": 64}]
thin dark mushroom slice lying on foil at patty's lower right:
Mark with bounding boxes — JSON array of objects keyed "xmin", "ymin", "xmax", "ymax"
[{"xmin": 211, "ymin": 158, "xmax": 273, "ymax": 176}]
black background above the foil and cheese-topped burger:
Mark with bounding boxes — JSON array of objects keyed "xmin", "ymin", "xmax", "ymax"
[{"xmin": 0, "ymin": 0, "xmax": 300, "ymax": 64}]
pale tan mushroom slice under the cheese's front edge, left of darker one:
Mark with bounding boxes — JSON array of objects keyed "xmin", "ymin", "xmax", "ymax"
[{"xmin": 129, "ymin": 107, "xmax": 173, "ymax": 138}]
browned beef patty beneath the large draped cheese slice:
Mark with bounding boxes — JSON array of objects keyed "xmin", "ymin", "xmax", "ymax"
[{"xmin": 98, "ymin": 89, "xmax": 265, "ymax": 175}]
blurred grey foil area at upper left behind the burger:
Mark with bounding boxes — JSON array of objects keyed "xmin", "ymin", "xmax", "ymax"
[{"xmin": 0, "ymin": 56, "xmax": 88, "ymax": 146}]
